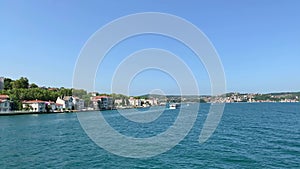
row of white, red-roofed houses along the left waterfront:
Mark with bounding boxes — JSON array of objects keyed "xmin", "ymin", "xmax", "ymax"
[{"xmin": 0, "ymin": 95, "xmax": 162, "ymax": 112}]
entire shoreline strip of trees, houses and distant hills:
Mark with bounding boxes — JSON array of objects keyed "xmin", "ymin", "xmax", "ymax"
[{"xmin": 0, "ymin": 77, "xmax": 300, "ymax": 113}]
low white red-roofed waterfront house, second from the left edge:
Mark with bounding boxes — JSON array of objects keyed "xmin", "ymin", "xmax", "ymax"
[{"xmin": 22, "ymin": 100, "xmax": 46, "ymax": 112}]
